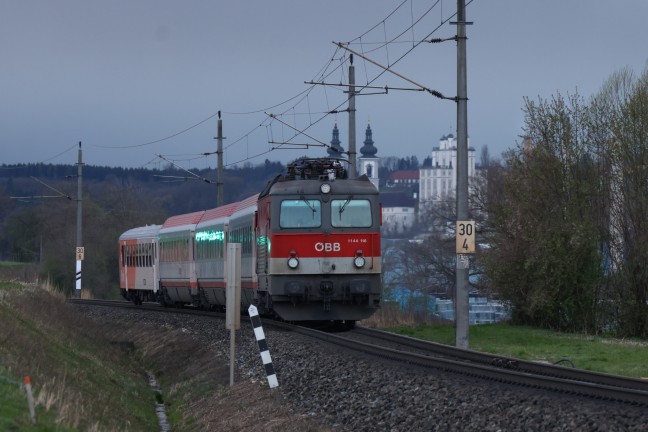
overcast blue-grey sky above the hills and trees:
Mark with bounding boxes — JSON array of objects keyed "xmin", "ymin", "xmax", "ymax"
[{"xmin": 0, "ymin": 0, "xmax": 648, "ymax": 168}]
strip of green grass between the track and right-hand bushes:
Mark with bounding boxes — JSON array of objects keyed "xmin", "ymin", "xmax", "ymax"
[{"xmin": 386, "ymin": 324, "xmax": 648, "ymax": 378}]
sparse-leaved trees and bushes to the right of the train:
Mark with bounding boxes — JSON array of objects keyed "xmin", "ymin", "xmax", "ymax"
[{"xmin": 383, "ymin": 69, "xmax": 648, "ymax": 338}]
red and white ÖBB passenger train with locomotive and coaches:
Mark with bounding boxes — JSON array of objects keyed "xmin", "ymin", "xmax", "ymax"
[{"xmin": 119, "ymin": 158, "xmax": 382, "ymax": 327}]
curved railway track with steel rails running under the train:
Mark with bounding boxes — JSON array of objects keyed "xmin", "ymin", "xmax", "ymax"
[{"xmin": 70, "ymin": 299, "xmax": 648, "ymax": 406}]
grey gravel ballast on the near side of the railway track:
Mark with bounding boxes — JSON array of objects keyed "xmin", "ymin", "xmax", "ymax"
[{"xmin": 79, "ymin": 306, "xmax": 648, "ymax": 431}]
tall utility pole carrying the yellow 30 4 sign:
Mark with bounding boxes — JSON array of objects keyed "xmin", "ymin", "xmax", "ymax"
[{"xmin": 455, "ymin": 0, "xmax": 470, "ymax": 349}]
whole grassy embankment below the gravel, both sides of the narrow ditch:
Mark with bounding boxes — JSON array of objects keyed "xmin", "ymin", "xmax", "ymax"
[{"xmin": 0, "ymin": 272, "xmax": 329, "ymax": 432}]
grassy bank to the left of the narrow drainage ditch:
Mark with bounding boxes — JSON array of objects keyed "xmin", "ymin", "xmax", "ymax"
[{"xmin": 0, "ymin": 282, "xmax": 157, "ymax": 431}]
